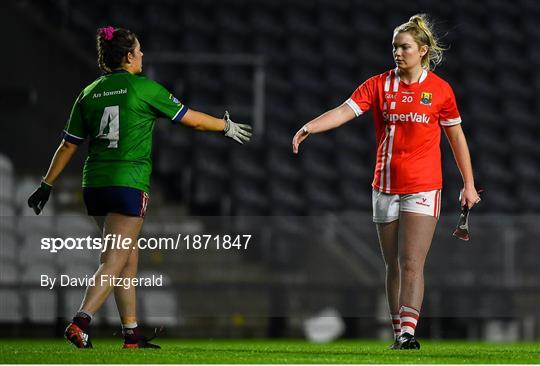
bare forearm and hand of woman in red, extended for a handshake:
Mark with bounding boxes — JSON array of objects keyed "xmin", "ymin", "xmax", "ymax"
[{"xmin": 292, "ymin": 103, "xmax": 356, "ymax": 154}]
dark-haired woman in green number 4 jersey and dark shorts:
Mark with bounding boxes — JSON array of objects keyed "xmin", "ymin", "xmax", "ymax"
[{"xmin": 28, "ymin": 27, "xmax": 251, "ymax": 348}]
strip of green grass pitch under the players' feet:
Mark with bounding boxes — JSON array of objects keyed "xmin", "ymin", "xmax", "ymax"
[{"xmin": 0, "ymin": 339, "xmax": 540, "ymax": 364}]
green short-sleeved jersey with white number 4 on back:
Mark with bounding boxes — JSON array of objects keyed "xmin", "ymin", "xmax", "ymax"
[{"xmin": 64, "ymin": 70, "xmax": 188, "ymax": 192}]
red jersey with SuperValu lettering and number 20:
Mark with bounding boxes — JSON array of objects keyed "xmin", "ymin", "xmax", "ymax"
[{"xmin": 345, "ymin": 69, "xmax": 461, "ymax": 194}]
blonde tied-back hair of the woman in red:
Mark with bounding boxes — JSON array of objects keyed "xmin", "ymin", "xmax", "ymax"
[{"xmin": 394, "ymin": 14, "xmax": 446, "ymax": 70}]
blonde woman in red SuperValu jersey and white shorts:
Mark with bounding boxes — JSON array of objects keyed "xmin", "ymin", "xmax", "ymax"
[{"xmin": 292, "ymin": 14, "xmax": 480, "ymax": 349}]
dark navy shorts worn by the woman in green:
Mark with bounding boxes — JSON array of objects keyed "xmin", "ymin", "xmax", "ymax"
[{"xmin": 83, "ymin": 187, "xmax": 148, "ymax": 217}]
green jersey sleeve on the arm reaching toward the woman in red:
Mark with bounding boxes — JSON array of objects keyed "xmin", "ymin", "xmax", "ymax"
[{"xmin": 137, "ymin": 78, "xmax": 188, "ymax": 123}]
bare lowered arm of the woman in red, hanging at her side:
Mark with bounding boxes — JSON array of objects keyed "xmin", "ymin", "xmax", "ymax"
[{"xmin": 444, "ymin": 124, "xmax": 480, "ymax": 208}]
